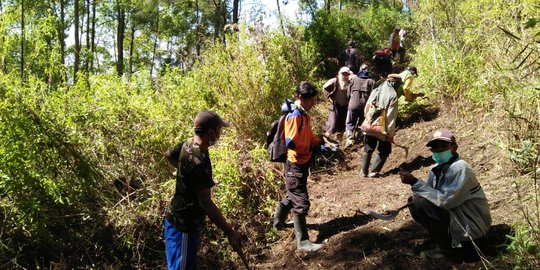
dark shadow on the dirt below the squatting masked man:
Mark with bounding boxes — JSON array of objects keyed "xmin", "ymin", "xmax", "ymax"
[{"xmin": 316, "ymin": 222, "xmax": 511, "ymax": 269}]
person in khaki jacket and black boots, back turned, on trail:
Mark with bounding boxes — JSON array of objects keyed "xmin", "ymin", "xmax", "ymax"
[{"xmin": 360, "ymin": 74, "xmax": 401, "ymax": 177}]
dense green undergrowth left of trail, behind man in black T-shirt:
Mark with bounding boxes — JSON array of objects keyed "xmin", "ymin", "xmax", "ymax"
[{"xmin": 0, "ymin": 20, "xmax": 316, "ymax": 268}]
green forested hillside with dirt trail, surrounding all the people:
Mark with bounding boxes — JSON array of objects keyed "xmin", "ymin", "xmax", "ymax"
[{"xmin": 0, "ymin": 0, "xmax": 540, "ymax": 269}]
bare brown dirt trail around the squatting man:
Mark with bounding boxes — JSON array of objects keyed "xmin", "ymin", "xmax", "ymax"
[{"xmin": 254, "ymin": 103, "xmax": 517, "ymax": 269}]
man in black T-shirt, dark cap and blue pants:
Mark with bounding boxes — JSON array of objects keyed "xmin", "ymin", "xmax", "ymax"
[{"xmin": 164, "ymin": 111, "xmax": 241, "ymax": 269}]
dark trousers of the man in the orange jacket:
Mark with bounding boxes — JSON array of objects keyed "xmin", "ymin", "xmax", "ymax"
[{"xmin": 281, "ymin": 160, "xmax": 311, "ymax": 215}]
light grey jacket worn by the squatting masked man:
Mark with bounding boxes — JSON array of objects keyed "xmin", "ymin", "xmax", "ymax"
[{"xmin": 411, "ymin": 156, "xmax": 491, "ymax": 247}]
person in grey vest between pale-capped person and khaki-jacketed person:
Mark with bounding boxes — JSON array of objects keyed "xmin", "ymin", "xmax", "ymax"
[{"xmin": 345, "ymin": 64, "xmax": 375, "ymax": 147}]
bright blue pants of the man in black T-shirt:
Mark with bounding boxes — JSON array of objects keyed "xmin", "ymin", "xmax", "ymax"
[{"xmin": 163, "ymin": 218, "xmax": 200, "ymax": 270}]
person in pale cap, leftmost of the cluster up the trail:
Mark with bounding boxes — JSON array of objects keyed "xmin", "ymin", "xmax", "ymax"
[{"xmin": 323, "ymin": 67, "xmax": 353, "ymax": 140}]
